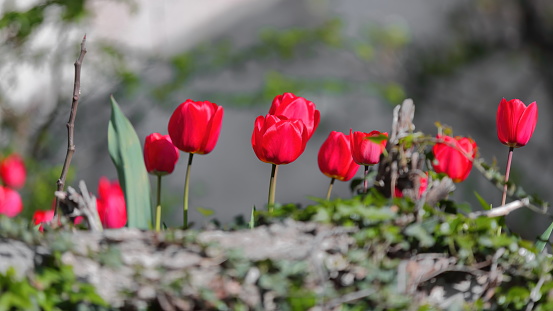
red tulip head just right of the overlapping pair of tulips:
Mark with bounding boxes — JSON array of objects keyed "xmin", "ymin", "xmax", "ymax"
[{"xmin": 318, "ymin": 131, "xmax": 359, "ymax": 181}]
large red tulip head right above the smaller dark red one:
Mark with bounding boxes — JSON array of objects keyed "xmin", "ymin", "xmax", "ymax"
[{"xmin": 168, "ymin": 99, "xmax": 224, "ymax": 154}]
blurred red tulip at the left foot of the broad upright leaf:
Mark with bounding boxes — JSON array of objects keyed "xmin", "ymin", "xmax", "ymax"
[{"xmin": 96, "ymin": 177, "xmax": 128, "ymax": 228}]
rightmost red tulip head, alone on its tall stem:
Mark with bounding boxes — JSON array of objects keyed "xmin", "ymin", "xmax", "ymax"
[{"xmin": 496, "ymin": 98, "xmax": 538, "ymax": 148}]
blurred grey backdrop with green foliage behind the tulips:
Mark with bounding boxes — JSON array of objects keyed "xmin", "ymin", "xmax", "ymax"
[{"xmin": 0, "ymin": 0, "xmax": 553, "ymax": 239}]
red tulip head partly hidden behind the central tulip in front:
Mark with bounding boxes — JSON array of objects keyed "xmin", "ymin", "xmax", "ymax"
[{"xmin": 269, "ymin": 93, "xmax": 321, "ymax": 139}]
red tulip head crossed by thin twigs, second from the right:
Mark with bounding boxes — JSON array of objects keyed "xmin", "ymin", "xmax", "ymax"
[{"xmin": 432, "ymin": 135, "xmax": 477, "ymax": 182}]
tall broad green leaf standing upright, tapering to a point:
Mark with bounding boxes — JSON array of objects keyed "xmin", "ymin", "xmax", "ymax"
[{"xmin": 108, "ymin": 96, "xmax": 152, "ymax": 229}]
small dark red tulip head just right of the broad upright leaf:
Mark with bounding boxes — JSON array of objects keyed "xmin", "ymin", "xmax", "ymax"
[{"xmin": 144, "ymin": 133, "xmax": 179, "ymax": 176}]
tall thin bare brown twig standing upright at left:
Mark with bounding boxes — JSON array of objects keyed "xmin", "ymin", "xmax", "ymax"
[{"xmin": 56, "ymin": 35, "xmax": 86, "ymax": 214}]
